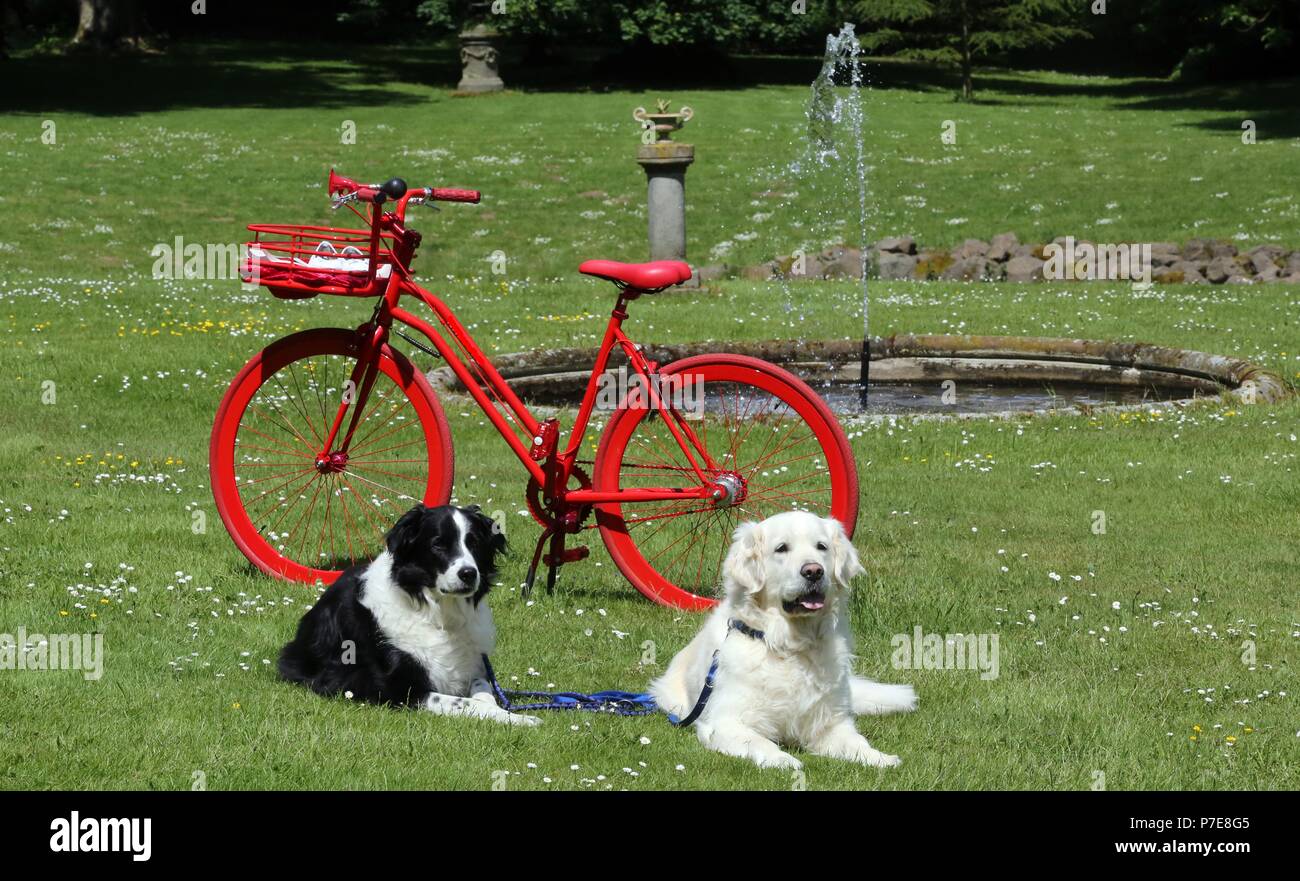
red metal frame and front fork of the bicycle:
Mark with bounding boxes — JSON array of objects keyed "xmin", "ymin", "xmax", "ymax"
[{"xmin": 310, "ymin": 198, "xmax": 725, "ymax": 509}]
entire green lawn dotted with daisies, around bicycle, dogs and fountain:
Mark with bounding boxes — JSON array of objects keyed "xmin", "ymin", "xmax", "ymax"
[{"xmin": 0, "ymin": 41, "xmax": 1300, "ymax": 789}]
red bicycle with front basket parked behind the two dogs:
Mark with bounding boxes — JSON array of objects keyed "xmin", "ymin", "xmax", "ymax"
[{"xmin": 209, "ymin": 172, "xmax": 858, "ymax": 609}]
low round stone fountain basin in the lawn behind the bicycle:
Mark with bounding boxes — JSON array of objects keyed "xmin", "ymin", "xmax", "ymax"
[{"xmin": 429, "ymin": 334, "xmax": 1288, "ymax": 416}]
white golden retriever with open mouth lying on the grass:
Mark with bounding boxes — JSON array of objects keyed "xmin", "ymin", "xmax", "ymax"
[{"xmin": 650, "ymin": 511, "xmax": 917, "ymax": 768}]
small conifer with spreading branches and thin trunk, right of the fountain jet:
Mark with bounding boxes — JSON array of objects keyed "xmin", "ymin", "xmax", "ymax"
[{"xmin": 857, "ymin": 0, "xmax": 1088, "ymax": 100}]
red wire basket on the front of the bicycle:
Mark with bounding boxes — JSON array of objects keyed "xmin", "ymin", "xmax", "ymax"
[{"xmin": 239, "ymin": 223, "xmax": 400, "ymax": 300}]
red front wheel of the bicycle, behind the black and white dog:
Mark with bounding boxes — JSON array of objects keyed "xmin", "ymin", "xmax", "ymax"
[{"xmin": 208, "ymin": 327, "xmax": 452, "ymax": 583}]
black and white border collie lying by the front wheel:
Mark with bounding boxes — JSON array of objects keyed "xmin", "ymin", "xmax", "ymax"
[{"xmin": 280, "ymin": 505, "xmax": 541, "ymax": 725}]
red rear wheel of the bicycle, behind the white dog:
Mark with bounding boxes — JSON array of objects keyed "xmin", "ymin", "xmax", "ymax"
[{"xmin": 594, "ymin": 355, "xmax": 858, "ymax": 609}]
